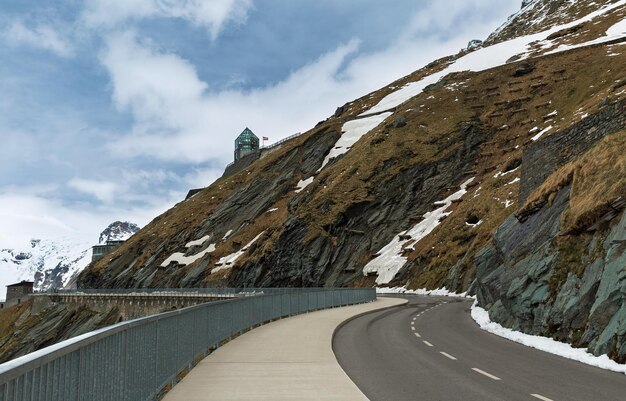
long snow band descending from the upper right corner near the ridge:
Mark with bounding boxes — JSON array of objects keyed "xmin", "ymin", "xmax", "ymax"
[{"xmin": 361, "ymin": 0, "xmax": 626, "ymax": 115}]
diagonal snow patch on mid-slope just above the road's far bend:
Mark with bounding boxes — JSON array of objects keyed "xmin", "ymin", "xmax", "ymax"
[{"xmin": 363, "ymin": 178, "xmax": 474, "ymax": 284}]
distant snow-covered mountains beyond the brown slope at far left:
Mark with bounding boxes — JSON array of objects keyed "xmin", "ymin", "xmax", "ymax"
[{"xmin": 0, "ymin": 221, "xmax": 139, "ymax": 290}]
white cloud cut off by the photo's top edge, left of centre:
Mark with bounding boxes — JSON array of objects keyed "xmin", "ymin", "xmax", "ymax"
[{"xmin": 83, "ymin": 0, "xmax": 252, "ymax": 39}]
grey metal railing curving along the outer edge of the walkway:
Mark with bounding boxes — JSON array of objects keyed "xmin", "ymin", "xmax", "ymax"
[{"xmin": 0, "ymin": 288, "xmax": 376, "ymax": 401}]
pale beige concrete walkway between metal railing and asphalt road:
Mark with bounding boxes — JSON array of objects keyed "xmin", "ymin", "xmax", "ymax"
[{"xmin": 164, "ymin": 298, "xmax": 406, "ymax": 401}]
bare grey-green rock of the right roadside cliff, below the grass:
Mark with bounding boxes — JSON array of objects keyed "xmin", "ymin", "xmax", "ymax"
[{"xmin": 474, "ymin": 188, "xmax": 626, "ymax": 363}]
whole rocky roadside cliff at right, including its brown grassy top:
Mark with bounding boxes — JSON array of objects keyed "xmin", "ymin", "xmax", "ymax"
[{"xmin": 474, "ymin": 128, "xmax": 626, "ymax": 363}]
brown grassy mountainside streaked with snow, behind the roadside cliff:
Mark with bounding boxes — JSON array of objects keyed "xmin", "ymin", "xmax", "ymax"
[{"xmin": 79, "ymin": 0, "xmax": 626, "ymax": 359}]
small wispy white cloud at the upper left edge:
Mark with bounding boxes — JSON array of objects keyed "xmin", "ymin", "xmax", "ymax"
[{"xmin": 1, "ymin": 21, "xmax": 73, "ymax": 57}]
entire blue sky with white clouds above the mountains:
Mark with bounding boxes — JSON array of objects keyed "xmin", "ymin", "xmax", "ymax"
[{"xmin": 0, "ymin": 0, "xmax": 520, "ymax": 248}]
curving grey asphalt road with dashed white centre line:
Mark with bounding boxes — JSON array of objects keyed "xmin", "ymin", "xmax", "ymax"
[{"xmin": 333, "ymin": 296, "xmax": 626, "ymax": 401}]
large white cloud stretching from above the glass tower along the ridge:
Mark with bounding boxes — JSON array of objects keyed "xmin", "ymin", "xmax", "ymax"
[{"xmin": 101, "ymin": 0, "xmax": 512, "ymax": 164}]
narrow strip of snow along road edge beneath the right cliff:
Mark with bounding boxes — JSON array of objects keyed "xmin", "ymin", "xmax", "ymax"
[{"xmin": 471, "ymin": 302, "xmax": 626, "ymax": 374}]
